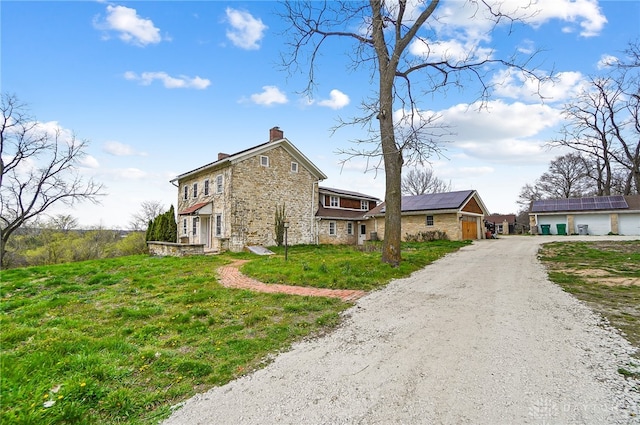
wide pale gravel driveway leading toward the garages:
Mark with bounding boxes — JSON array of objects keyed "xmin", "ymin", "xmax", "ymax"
[{"xmin": 165, "ymin": 236, "xmax": 640, "ymax": 425}]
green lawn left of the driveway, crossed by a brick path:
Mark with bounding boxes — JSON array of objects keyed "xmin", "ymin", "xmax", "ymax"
[{"xmin": 0, "ymin": 242, "xmax": 464, "ymax": 424}]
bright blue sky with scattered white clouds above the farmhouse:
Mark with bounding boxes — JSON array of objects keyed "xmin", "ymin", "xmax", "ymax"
[{"xmin": 0, "ymin": 0, "xmax": 640, "ymax": 228}]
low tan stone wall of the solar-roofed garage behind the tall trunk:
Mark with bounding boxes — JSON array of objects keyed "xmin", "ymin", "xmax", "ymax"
[{"xmin": 367, "ymin": 213, "xmax": 462, "ymax": 241}]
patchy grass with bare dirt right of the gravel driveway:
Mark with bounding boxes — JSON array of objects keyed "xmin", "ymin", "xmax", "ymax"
[{"xmin": 540, "ymin": 241, "xmax": 640, "ymax": 358}]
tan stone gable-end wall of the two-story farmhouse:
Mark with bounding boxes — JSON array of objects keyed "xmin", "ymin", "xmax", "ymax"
[{"xmin": 230, "ymin": 146, "xmax": 318, "ymax": 251}]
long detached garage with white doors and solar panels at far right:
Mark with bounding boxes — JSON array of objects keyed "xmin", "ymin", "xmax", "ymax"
[{"xmin": 529, "ymin": 195, "xmax": 640, "ymax": 235}]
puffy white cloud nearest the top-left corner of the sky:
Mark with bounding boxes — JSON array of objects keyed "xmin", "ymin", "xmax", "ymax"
[{"xmin": 93, "ymin": 5, "xmax": 162, "ymax": 46}]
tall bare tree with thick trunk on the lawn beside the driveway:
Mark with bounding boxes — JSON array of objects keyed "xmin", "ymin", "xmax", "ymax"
[{"xmin": 283, "ymin": 0, "xmax": 548, "ymax": 266}]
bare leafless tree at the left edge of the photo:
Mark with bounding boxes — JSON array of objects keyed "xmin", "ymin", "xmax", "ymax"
[{"xmin": 0, "ymin": 94, "xmax": 103, "ymax": 264}]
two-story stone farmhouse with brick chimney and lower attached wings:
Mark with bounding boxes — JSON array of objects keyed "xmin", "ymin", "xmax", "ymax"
[{"xmin": 171, "ymin": 127, "xmax": 486, "ymax": 252}]
